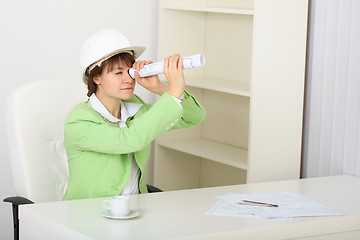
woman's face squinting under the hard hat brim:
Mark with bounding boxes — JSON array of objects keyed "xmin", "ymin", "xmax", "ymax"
[{"xmin": 94, "ymin": 60, "xmax": 135, "ymax": 100}]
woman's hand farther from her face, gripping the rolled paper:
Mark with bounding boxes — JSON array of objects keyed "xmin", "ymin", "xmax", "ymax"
[{"xmin": 164, "ymin": 54, "xmax": 185, "ymax": 99}]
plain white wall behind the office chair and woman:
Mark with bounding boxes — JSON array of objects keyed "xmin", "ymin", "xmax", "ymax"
[{"xmin": 0, "ymin": 0, "xmax": 158, "ymax": 239}]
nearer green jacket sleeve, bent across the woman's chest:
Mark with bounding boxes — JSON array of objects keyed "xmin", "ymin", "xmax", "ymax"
[{"xmin": 65, "ymin": 93, "xmax": 183, "ymax": 154}]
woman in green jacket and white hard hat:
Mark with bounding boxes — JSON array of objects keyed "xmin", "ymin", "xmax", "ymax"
[{"xmin": 64, "ymin": 29, "xmax": 206, "ymax": 200}]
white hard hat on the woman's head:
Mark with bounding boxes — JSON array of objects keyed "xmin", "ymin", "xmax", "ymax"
[{"xmin": 80, "ymin": 28, "xmax": 145, "ymax": 84}]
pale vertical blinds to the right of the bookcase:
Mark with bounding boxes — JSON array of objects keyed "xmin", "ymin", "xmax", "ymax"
[{"xmin": 302, "ymin": 0, "xmax": 360, "ymax": 177}]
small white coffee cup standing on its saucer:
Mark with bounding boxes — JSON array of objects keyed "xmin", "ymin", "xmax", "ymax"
[{"xmin": 103, "ymin": 196, "xmax": 130, "ymax": 217}]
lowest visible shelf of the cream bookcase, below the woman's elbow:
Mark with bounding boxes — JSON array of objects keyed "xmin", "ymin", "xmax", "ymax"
[{"xmin": 157, "ymin": 139, "xmax": 248, "ymax": 170}]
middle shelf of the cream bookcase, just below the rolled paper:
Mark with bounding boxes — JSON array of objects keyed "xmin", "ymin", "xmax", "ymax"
[{"xmin": 161, "ymin": 76, "xmax": 250, "ymax": 97}]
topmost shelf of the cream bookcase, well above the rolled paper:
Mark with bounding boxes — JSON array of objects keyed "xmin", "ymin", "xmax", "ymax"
[{"xmin": 163, "ymin": 4, "xmax": 254, "ymax": 15}]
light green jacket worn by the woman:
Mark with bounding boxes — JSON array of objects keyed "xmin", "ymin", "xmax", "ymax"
[{"xmin": 64, "ymin": 91, "xmax": 206, "ymax": 200}]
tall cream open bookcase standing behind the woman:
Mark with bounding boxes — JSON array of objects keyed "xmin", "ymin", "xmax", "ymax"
[{"xmin": 154, "ymin": 0, "xmax": 308, "ymax": 190}]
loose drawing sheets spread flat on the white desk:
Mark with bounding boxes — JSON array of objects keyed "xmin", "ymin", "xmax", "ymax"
[{"xmin": 206, "ymin": 192, "xmax": 341, "ymax": 219}]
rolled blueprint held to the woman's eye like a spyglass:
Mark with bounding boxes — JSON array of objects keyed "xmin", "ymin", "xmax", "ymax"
[{"xmin": 129, "ymin": 53, "xmax": 205, "ymax": 78}]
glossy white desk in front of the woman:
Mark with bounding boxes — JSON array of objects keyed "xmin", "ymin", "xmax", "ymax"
[{"xmin": 19, "ymin": 176, "xmax": 360, "ymax": 240}]
